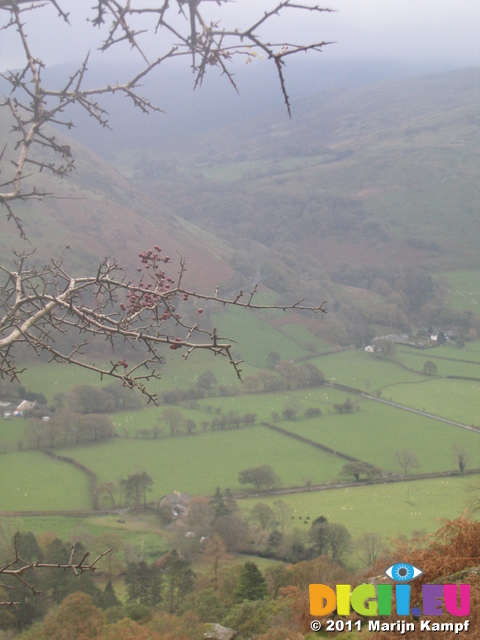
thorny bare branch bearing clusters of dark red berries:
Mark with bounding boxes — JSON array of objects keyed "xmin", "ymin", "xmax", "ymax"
[{"xmin": 0, "ymin": 250, "xmax": 325, "ymax": 402}]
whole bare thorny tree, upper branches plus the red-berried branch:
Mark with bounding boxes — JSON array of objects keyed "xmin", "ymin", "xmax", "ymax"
[{"xmin": 0, "ymin": 0, "xmax": 330, "ymax": 400}]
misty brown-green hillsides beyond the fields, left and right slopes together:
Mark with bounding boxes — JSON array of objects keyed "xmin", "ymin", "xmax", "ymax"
[{"xmin": 0, "ymin": 69, "xmax": 480, "ymax": 364}]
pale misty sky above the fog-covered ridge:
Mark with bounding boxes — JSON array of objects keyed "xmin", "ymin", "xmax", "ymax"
[{"xmin": 0, "ymin": 0, "xmax": 480, "ymax": 69}]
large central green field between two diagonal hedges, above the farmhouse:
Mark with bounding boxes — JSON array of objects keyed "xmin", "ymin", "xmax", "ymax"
[{"xmin": 61, "ymin": 427, "xmax": 341, "ymax": 499}]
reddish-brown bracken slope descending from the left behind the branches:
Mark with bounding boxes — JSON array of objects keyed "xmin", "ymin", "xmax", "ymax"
[{"xmin": 0, "ymin": 115, "xmax": 231, "ymax": 289}]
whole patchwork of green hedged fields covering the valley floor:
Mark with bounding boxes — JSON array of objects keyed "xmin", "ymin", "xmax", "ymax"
[{"xmin": 0, "ymin": 340, "xmax": 480, "ymax": 557}]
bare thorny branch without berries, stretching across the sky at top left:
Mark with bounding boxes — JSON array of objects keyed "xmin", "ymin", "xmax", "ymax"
[{"xmin": 0, "ymin": 0, "xmax": 331, "ymax": 228}]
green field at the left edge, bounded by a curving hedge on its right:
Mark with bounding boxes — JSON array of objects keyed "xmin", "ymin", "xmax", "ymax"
[{"xmin": 0, "ymin": 451, "xmax": 92, "ymax": 511}]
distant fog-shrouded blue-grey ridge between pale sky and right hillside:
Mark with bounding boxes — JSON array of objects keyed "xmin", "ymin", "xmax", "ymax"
[{"xmin": 44, "ymin": 55, "xmax": 476, "ymax": 157}]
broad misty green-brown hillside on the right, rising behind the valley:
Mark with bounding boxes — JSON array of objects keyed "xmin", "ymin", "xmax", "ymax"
[{"xmin": 124, "ymin": 69, "xmax": 480, "ymax": 273}]
